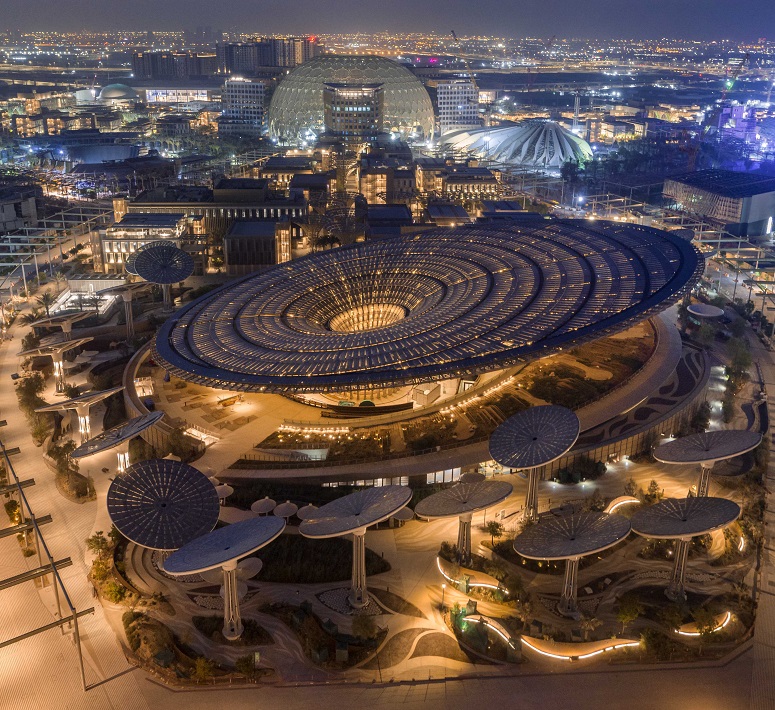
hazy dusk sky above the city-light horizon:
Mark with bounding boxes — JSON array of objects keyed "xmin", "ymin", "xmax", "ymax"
[{"xmin": 0, "ymin": 0, "xmax": 775, "ymax": 40}]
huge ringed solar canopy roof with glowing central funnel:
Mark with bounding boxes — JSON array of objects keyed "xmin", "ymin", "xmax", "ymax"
[{"xmin": 153, "ymin": 220, "xmax": 702, "ymax": 392}]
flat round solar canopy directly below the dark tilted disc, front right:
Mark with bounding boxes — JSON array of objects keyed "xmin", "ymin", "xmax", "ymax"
[{"xmin": 514, "ymin": 511, "xmax": 630, "ymax": 560}]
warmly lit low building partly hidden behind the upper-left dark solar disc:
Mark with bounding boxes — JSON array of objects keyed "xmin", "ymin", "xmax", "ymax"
[{"xmin": 94, "ymin": 212, "xmax": 207, "ymax": 275}]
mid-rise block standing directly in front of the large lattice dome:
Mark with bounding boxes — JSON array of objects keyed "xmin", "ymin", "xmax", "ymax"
[{"xmin": 323, "ymin": 84, "xmax": 384, "ymax": 143}]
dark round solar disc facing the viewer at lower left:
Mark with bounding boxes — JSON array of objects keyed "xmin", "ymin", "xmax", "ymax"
[{"xmin": 108, "ymin": 459, "xmax": 220, "ymax": 550}]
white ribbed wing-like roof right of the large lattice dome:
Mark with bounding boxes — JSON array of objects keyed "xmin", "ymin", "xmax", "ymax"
[{"xmin": 439, "ymin": 121, "xmax": 592, "ymax": 168}]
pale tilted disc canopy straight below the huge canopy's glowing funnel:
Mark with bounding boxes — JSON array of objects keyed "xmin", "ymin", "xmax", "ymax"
[{"xmin": 299, "ymin": 486, "xmax": 412, "ymax": 538}]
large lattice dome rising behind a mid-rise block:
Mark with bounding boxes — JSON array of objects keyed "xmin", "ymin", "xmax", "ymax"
[{"xmin": 269, "ymin": 54, "xmax": 433, "ymax": 143}]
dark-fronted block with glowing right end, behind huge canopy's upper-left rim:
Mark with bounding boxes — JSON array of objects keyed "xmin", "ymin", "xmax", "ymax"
[{"xmin": 223, "ymin": 219, "xmax": 291, "ymax": 276}]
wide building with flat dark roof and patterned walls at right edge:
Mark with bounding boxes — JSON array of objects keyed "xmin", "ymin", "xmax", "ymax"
[{"xmin": 662, "ymin": 170, "xmax": 775, "ymax": 237}]
